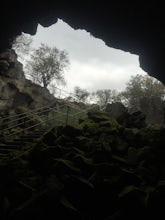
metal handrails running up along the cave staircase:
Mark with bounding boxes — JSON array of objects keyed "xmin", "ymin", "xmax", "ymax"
[{"xmin": 0, "ymin": 101, "xmax": 99, "ymax": 142}]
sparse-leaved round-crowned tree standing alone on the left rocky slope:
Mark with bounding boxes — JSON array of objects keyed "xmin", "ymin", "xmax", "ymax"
[{"xmin": 26, "ymin": 43, "xmax": 69, "ymax": 88}]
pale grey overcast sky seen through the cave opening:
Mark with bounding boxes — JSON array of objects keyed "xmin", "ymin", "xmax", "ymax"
[{"xmin": 29, "ymin": 20, "xmax": 146, "ymax": 92}]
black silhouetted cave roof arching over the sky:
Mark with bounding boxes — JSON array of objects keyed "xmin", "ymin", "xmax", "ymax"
[{"xmin": 0, "ymin": 0, "xmax": 165, "ymax": 82}]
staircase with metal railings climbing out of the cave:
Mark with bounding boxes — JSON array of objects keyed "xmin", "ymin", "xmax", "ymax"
[{"xmin": 0, "ymin": 103, "xmax": 98, "ymax": 161}]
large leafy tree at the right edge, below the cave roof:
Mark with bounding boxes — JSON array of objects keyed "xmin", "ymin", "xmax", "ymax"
[{"xmin": 120, "ymin": 75, "xmax": 165, "ymax": 123}]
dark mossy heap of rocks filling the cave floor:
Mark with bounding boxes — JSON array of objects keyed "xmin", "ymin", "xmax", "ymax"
[{"xmin": 0, "ymin": 111, "xmax": 165, "ymax": 220}]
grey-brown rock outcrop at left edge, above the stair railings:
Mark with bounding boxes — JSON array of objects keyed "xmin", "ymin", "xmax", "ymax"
[{"xmin": 0, "ymin": 49, "xmax": 54, "ymax": 112}]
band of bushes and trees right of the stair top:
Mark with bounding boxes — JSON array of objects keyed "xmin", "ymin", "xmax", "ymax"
[{"xmin": 75, "ymin": 75, "xmax": 165, "ymax": 124}]
